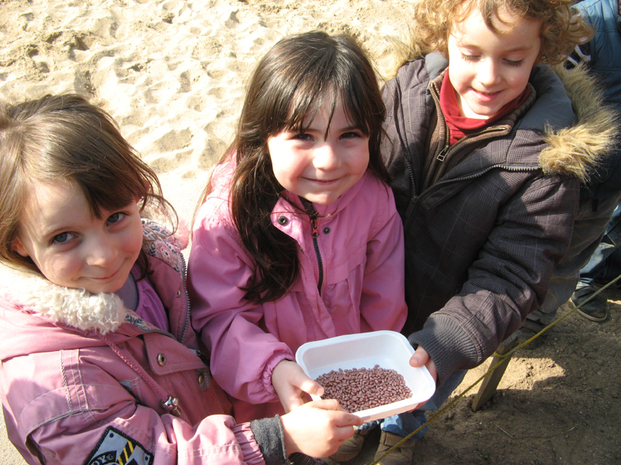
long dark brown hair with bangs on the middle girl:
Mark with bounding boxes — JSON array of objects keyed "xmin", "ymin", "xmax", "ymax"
[{"xmin": 203, "ymin": 31, "xmax": 389, "ymax": 303}]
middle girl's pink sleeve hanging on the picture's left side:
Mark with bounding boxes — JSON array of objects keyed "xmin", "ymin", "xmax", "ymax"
[{"xmin": 188, "ymin": 205, "xmax": 293, "ymax": 404}]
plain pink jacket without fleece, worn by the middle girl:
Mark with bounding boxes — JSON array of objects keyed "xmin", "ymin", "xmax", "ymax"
[{"xmin": 188, "ymin": 163, "xmax": 407, "ymax": 421}]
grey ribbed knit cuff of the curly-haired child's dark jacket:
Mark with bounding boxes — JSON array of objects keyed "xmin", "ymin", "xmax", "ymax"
[{"xmin": 408, "ymin": 316, "xmax": 478, "ymax": 386}]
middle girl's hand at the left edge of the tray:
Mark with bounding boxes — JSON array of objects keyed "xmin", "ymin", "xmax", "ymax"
[{"xmin": 272, "ymin": 360, "xmax": 323, "ymax": 412}]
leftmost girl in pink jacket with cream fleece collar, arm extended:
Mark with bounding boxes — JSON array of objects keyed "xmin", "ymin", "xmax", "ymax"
[{"xmin": 0, "ymin": 95, "xmax": 360, "ymax": 465}]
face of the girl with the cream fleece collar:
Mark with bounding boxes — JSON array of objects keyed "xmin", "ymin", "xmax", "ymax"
[{"xmin": 12, "ymin": 182, "xmax": 142, "ymax": 294}]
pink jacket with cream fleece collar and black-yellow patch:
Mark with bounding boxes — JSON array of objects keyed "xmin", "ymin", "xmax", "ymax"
[{"xmin": 0, "ymin": 220, "xmax": 272, "ymax": 465}]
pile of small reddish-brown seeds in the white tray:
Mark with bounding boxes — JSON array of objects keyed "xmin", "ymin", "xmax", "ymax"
[{"xmin": 315, "ymin": 365, "xmax": 412, "ymax": 412}]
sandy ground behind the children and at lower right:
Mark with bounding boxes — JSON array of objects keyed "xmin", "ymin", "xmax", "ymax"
[{"xmin": 0, "ymin": 0, "xmax": 621, "ymax": 465}]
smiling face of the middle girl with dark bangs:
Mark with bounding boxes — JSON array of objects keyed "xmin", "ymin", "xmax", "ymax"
[{"xmin": 267, "ymin": 99, "xmax": 369, "ymax": 205}]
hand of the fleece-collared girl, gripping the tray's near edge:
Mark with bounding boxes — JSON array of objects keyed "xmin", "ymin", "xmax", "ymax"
[{"xmin": 280, "ymin": 399, "xmax": 362, "ymax": 457}]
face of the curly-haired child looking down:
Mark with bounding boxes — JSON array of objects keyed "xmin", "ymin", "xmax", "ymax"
[{"xmin": 448, "ymin": 8, "xmax": 541, "ymax": 119}]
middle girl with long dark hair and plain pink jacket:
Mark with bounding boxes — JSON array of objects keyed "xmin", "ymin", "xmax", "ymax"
[{"xmin": 188, "ymin": 32, "xmax": 406, "ymax": 426}]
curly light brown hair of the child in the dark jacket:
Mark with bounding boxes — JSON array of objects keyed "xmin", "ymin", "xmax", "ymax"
[{"xmin": 407, "ymin": 0, "xmax": 593, "ymax": 65}]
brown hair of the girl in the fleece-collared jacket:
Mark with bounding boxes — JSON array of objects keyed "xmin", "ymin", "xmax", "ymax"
[{"xmin": 0, "ymin": 94, "xmax": 177, "ymax": 274}]
